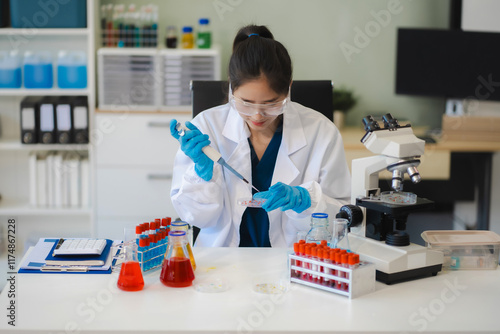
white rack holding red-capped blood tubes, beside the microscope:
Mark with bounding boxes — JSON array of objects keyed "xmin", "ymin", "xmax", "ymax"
[{"xmin": 288, "ymin": 254, "xmax": 375, "ymax": 299}]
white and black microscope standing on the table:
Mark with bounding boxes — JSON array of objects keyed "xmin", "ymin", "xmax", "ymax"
[{"xmin": 337, "ymin": 114, "xmax": 443, "ymax": 284}]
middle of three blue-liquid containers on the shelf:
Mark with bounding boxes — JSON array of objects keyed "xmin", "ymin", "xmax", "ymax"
[{"xmin": 24, "ymin": 51, "xmax": 54, "ymax": 88}]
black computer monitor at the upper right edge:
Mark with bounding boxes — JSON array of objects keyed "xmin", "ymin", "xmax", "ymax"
[{"xmin": 396, "ymin": 28, "xmax": 500, "ymax": 101}]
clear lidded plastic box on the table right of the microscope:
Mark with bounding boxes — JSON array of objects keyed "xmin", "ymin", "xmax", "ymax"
[{"xmin": 422, "ymin": 230, "xmax": 500, "ymax": 270}]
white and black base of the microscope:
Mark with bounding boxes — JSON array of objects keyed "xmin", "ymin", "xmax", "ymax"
[{"xmin": 348, "ymin": 233, "xmax": 443, "ymax": 284}]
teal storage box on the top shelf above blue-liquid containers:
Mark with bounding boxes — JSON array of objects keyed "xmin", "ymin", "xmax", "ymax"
[{"xmin": 10, "ymin": 0, "xmax": 87, "ymax": 28}]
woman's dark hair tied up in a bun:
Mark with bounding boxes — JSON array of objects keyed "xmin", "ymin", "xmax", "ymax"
[{"xmin": 229, "ymin": 25, "xmax": 292, "ymax": 94}]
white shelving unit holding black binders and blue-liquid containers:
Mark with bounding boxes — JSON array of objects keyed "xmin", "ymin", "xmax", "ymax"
[{"xmin": 0, "ymin": 0, "xmax": 97, "ymax": 249}]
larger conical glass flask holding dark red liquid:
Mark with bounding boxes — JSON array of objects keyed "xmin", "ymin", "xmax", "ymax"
[{"xmin": 160, "ymin": 231, "xmax": 194, "ymax": 288}]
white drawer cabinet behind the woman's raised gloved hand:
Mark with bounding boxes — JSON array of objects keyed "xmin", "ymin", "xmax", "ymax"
[{"xmin": 95, "ymin": 112, "xmax": 191, "ymax": 238}]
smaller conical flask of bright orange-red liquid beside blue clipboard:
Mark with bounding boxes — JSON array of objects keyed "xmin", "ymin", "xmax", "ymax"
[{"xmin": 117, "ymin": 240, "xmax": 144, "ymax": 291}]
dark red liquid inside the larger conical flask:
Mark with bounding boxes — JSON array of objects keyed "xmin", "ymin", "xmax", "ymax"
[{"xmin": 160, "ymin": 257, "xmax": 194, "ymax": 288}]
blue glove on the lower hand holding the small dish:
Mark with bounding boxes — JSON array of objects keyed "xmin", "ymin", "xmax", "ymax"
[{"xmin": 253, "ymin": 182, "xmax": 311, "ymax": 213}]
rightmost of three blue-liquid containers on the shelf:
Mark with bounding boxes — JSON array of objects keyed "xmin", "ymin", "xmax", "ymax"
[{"xmin": 57, "ymin": 51, "xmax": 87, "ymax": 88}]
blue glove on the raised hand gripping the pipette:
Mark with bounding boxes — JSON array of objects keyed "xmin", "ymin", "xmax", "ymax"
[{"xmin": 170, "ymin": 119, "xmax": 214, "ymax": 181}]
